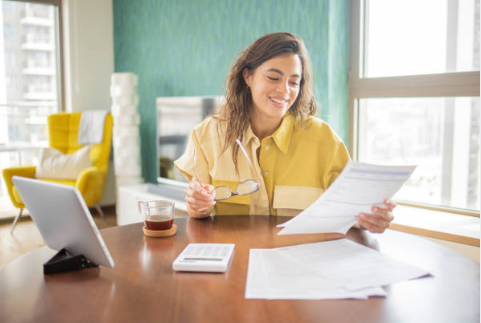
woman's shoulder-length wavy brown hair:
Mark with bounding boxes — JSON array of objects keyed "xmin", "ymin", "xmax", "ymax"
[{"xmin": 218, "ymin": 32, "xmax": 318, "ymax": 170}]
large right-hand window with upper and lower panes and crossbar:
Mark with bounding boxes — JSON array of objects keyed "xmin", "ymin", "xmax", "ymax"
[{"xmin": 349, "ymin": 0, "xmax": 481, "ymax": 215}]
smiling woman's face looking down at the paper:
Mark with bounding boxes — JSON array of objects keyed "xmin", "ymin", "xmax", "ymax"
[{"xmin": 244, "ymin": 54, "xmax": 302, "ymax": 122}]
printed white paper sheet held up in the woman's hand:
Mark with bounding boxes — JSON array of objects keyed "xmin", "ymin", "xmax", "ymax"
[{"xmin": 278, "ymin": 161, "xmax": 416, "ymax": 234}]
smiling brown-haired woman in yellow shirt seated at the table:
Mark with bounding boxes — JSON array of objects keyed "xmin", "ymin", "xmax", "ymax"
[{"xmin": 175, "ymin": 32, "xmax": 395, "ymax": 232}]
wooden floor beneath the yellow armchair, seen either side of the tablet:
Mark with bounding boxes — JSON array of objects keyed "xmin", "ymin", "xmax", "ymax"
[{"xmin": 0, "ymin": 206, "xmax": 117, "ymax": 269}]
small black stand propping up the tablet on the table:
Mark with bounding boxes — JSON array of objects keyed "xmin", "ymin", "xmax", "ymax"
[{"xmin": 43, "ymin": 249, "xmax": 99, "ymax": 274}]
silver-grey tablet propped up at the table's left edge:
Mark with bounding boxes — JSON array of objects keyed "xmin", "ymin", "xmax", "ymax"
[{"xmin": 12, "ymin": 176, "xmax": 114, "ymax": 268}]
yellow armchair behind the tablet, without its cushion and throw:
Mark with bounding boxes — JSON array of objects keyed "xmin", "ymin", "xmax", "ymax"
[{"xmin": 2, "ymin": 112, "xmax": 113, "ymax": 233}]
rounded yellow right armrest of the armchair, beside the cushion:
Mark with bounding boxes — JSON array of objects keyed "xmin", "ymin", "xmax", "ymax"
[{"xmin": 75, "ymin": 166, "xmax": 107, "ymax": 207}]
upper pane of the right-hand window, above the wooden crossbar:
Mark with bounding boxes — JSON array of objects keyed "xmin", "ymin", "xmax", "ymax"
[{"xmin": 363, "ymin": 0, "xmax": 479, "ymax": 77}]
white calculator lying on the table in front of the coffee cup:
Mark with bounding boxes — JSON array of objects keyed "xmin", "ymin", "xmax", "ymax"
[{"xmin": 172, "ymin": 243, "xmax": 235, "ymax": 273}]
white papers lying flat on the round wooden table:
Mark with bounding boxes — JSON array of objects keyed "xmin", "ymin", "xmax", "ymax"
[{"xmin": 245, "ymin": 239, "xmax": 429, "ymax": 299}]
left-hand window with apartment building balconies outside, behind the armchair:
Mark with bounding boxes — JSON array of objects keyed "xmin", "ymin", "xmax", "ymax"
[{"xmin": 0, "ymin": 0, "xmax": 62, "ymax": 216}]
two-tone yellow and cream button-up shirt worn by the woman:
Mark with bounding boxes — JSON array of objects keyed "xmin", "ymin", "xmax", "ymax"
[{"xmin": 175, "ymin": 114, "xmax": 349, "ymax": 215}]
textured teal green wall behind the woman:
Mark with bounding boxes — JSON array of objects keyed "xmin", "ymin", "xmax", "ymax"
[{"xmin": 113, "ymin": 0, "xmax": 349, "ymax": 182}]
